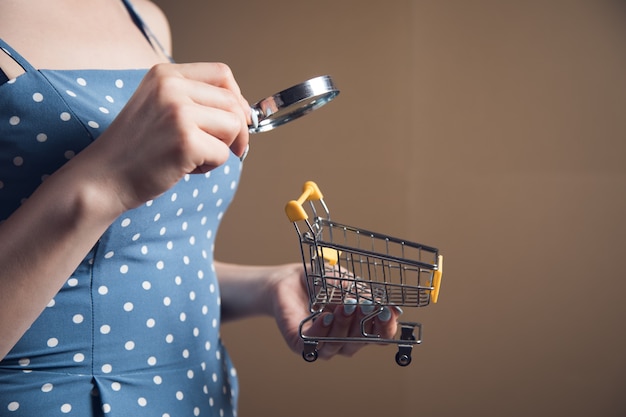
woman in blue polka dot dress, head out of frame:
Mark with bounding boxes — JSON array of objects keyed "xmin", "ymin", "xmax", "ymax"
[{"xmin": 0, "ymin": 0, "xmax": 397, "ymax": 417}]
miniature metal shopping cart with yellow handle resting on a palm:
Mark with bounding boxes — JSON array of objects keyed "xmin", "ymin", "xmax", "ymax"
[{"xmin": 285, "ymin": 181, "xmax": 443, "ymax": 366}]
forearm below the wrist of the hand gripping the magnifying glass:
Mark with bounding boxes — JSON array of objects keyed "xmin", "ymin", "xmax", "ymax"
[{"xmin": 0, "ymin": 156, "xmax": 123, "ymax": 359}]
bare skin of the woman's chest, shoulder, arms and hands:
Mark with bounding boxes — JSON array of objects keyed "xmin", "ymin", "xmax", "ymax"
[{"xmin": 0, "ymin": 0, "xmax": 397, "ymax": 358}]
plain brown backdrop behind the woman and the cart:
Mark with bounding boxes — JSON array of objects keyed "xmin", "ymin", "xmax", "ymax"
[{"xmin": 152, "ymin": 0, "xmax": 626, "ymax": 417}]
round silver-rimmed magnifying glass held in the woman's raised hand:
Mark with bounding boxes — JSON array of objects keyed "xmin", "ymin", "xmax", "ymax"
[{"xmin": 248, "ymin": 75, "xmax": 339, "ymax": 133}]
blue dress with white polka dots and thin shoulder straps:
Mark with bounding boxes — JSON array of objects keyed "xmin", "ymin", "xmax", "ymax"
[{"xmin": 0, "ymin": 4, "xmax": 242, "ymax": 417}]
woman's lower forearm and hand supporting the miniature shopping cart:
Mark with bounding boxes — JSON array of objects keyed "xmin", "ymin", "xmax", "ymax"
[{"xmin": 215, "ymin": 262, "xmax": 399, "ymax": 359}]
